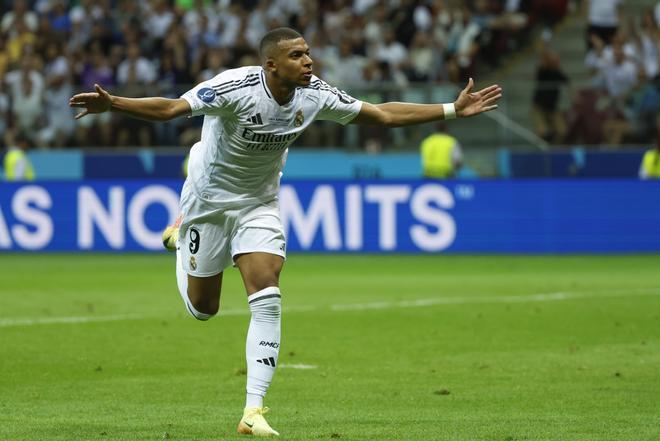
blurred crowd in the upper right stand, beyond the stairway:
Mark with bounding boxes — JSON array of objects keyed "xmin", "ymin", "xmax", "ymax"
[{"xmin": 533, "ymin": 0, "xmax": 660, "ymax": 147}]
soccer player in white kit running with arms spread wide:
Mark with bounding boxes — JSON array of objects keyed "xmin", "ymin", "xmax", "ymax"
[{"xmin": 69, "ymin": 28, "xmax": 502, "ymax": 436}]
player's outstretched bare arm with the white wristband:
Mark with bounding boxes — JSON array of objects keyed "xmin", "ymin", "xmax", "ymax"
[{"xmin": 352, "ymin": 78, "xmax": 502, "ymax": 127}]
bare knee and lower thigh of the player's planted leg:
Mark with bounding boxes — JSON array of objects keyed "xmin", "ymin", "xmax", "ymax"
[{"xmin": 234, "ymin": 252, "xmax": 284, "ymax": 295}]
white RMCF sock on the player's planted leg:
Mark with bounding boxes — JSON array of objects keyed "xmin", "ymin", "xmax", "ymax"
[{"xmin": 245, "ymin": 286, "xmax": 282, "ymax": 407}]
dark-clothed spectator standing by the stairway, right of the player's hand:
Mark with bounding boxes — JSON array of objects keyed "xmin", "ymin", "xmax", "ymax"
[{"xmin": 533, "ymin": 43, "xmax": 569, "ymax": 144}]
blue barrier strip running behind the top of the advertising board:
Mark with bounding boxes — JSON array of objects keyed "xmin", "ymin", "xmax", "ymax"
[{"xmin": 16, "ymin": 148, "xmax": 644, "ymax": 180}]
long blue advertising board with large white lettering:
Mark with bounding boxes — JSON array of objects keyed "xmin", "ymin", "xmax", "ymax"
[{"xmin": 0, "ymin": 180, "xmax": 660, "ymax": 253}]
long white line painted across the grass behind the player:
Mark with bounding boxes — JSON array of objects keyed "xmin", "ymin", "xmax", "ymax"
[{"xmin": 0, "ymin": 288, "xmax": 660, "ymax": 328}]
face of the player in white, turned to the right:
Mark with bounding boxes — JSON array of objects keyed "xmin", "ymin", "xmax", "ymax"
[{"xmin": 274, "ymin": 38, "xmax": 314, "ymax": 87}]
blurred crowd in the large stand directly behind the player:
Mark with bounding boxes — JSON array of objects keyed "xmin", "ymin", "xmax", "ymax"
[{"xmin": 0, "ymin": 0, "xmax": 552, "ymax": 147}]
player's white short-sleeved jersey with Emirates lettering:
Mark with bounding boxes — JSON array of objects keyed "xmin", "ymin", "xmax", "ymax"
[{"xmin": 181, "ymin": 66, "xmax": 362, "ymax": 207}]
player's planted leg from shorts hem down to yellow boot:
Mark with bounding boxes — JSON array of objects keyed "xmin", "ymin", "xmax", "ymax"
[{"xmin": 235, "ymin": 252, "xmax": 284, "ymax": 436}]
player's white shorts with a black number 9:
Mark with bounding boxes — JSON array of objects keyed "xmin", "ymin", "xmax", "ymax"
[{"xmin": 178, "ymin": 186, "xmax": 286, "ymax": 277}]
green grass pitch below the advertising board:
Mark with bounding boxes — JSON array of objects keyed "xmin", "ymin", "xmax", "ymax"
[{"xmin": 0, "ymin": 254, "xmax": 660, "ymax": 441}]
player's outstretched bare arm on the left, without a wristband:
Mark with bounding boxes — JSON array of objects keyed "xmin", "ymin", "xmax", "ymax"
[{"xmin": 69, "ymin": 84, "xmax": 191, "ymax": 121}]
